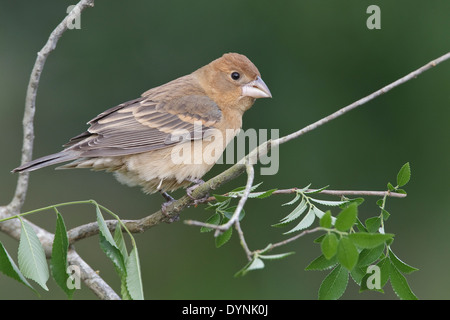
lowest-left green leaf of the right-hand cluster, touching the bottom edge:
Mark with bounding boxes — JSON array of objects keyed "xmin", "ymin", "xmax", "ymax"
[{"xmin": 319, "ymin": 266, "xmax": 348, "ymax": 300}]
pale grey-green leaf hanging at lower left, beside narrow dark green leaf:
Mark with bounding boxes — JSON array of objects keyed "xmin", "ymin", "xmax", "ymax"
[{"xmin": 18, "ymin": 219, "xmax": 49, "ymax": 291}]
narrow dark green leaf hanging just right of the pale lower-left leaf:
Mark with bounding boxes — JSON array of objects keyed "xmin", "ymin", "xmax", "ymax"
[{"xmin": 50, "ymin": 208, "xmax": 75, "ymax": 299}]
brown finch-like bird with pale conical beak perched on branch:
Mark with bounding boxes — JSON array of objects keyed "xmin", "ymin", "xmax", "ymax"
[{"xmin": 13, "ymin": 53, "xmax": 272, "ymax": 208}]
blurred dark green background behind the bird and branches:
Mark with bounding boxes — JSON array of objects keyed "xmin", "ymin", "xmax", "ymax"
[{"xmin": 0, "ymin": 0, "xmax": 450, "ymax": 299}]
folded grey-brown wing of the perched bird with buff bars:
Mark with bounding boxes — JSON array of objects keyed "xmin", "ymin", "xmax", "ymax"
[{"xmin": 65, "ymin": 86, "xmax": 222, "ymax": 157}]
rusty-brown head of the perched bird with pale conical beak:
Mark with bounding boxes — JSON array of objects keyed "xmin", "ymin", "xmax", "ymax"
[{"xmin": 198, "ymin": 53, "xmax": 272, "ymax": 112}]
